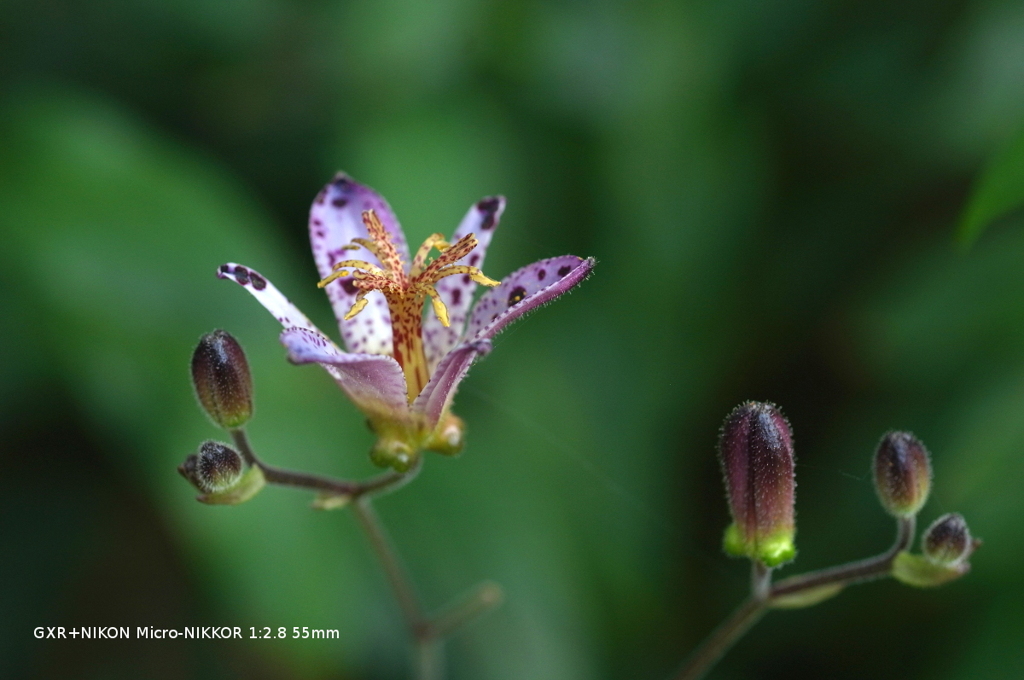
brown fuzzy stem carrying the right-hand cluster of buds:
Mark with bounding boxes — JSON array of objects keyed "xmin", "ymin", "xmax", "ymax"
[{"xmin": 673, "ymin": 517, "xmax": 914, "ymax": 680}]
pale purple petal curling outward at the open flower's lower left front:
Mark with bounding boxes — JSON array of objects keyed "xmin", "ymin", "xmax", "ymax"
[{"xmin": 281, "ymin": 328, "xmax": 409, "ymax": 420}]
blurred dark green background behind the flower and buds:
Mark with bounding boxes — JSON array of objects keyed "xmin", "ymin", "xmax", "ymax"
[{"xmin": 0, "ymin": 0, "xmax": 1024, "ymax": 680}]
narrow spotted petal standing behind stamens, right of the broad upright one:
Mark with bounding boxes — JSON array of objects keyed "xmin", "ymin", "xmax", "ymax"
[{"xmin": 423, "ymin": 196, "xmax": 505, "ymax": 370}]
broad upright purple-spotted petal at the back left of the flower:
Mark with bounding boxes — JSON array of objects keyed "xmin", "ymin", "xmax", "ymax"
[{"xmin": 309, "ymin": 173, "xmax": 409, "ymax": 354}]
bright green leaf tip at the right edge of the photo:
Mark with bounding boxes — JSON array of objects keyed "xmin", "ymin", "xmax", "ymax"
[{"xmin": 957, "ymin": 125, "xmax": 1024, "ymax": 246}]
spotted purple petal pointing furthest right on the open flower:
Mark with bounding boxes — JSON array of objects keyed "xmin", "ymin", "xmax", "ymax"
[{"xmin": 465, "ymin": 255, "xmax": 594, "ymax": 342}]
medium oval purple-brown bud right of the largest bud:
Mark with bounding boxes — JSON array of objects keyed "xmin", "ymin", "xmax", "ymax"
[{"xmin": 872, "ymin": 432, "xmax": 932, "ymax": 517}]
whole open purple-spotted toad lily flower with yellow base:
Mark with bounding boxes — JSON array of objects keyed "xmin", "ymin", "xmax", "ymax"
[{"xmin": 217, "ymin": 174, "xmax": 594, "ymax": 471}]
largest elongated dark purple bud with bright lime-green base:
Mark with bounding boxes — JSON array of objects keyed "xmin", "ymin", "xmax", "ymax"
[{"xmin": 718, "ymin": 401, "xmax": 797, "ymax": 566}]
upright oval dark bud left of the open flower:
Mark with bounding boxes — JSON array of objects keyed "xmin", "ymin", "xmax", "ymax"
[{"xmin": 191, "ymin": 331, "xmax": 253, "ymax": 430}]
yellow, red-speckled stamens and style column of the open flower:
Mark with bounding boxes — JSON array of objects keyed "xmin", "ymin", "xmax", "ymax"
[{"xmin": 316, "ymin": 210, "xmax": 500, "ymax": 402}]
